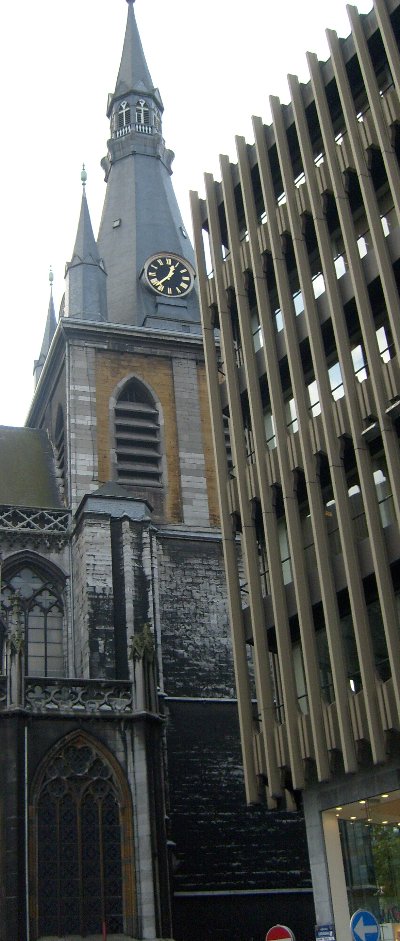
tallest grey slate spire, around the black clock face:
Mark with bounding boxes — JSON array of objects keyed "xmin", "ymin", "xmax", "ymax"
[{"xmin": 97, "ymin": 0, "xmax": 200, "ymax": 333}]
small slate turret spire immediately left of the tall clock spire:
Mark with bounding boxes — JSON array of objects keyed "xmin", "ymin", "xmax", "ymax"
[{"xmin": 64, "ymin": 165, "xmax": 107, "ymax": 320}]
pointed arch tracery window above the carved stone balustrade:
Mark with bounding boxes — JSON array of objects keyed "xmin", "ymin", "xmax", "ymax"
[{"xmin": 0, "ymin": 565, "xmax": 64, "ymax": 676}]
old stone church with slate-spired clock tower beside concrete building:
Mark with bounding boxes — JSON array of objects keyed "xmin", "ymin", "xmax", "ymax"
[{"xmin": 0, "ymin": 0, "xmax": 309, "ymax": 941}]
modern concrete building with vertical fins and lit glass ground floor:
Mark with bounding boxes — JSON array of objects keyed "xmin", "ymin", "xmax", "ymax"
[{"xmin": 192, "ymin": 0, "xmax": 400, "ymax": 941}]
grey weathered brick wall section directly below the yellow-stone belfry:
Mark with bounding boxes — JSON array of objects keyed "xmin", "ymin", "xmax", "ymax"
[{"xmin": 158, "ymin": 533, "xmax": 235, "ymax": 696}]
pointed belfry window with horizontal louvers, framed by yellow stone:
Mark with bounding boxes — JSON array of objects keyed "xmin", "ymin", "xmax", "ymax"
[{"xmin": 115, "ymin": 379, "xmax": 161, "ymax": 487}]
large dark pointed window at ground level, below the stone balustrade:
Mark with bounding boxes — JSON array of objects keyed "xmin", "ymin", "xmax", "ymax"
[{"xmin": 31, "ymin": 733, "xmax": 134, "ymax": 938}]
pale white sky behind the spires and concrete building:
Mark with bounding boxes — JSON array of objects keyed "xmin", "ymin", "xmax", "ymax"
[{"xmin": 0, "ymin": 0, "xmax": 372, "ymax": 425}]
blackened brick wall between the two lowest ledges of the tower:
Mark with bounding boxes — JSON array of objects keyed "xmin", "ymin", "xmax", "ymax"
[{"xmin": 166, "ymin": 701, "xmax": 310, "ymax": 891}]
